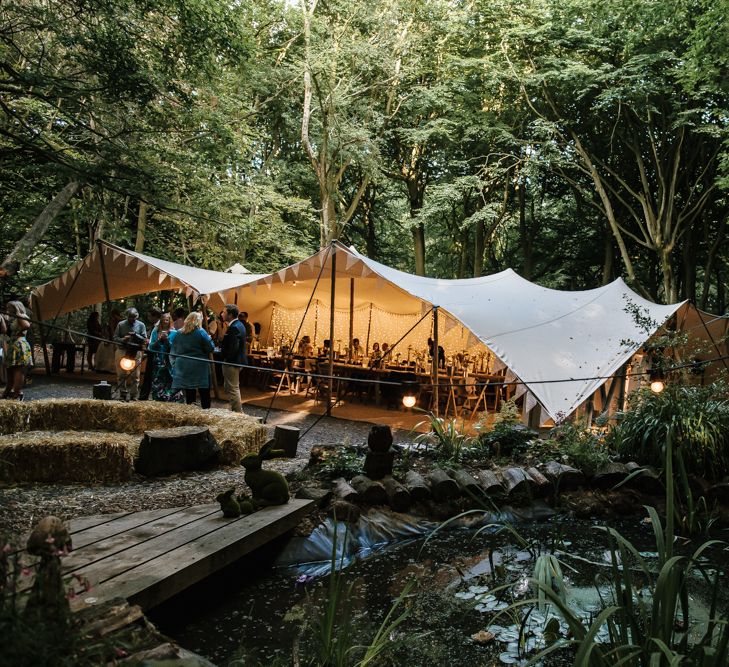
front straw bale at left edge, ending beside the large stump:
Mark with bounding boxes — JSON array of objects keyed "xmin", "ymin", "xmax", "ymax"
[{"xmin": 0, "ymin": 431, "xmax": 139, "ymax": 483}]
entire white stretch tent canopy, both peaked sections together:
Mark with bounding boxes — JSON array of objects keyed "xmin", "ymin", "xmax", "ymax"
[{"xmin": 33, "ymin": 242, "xmax": 700, "ymax": 419}]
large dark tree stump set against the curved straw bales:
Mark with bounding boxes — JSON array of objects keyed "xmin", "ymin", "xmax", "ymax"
[{"xmin": 135, "ymin": 426, "xmax": 220, "ymax": 477}]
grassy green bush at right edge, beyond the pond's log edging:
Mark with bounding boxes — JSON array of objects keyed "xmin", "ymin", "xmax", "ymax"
[{"xmin": 607, "ymin": 385, "xmax": 729, "ymax": 480}]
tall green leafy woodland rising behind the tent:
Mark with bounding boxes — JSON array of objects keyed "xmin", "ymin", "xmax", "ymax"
[{"xmin": 0, "ymin": 0, "xmax": 729, "ymax": 313}]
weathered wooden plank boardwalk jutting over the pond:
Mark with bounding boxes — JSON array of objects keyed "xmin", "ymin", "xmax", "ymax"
[{"xmin": 36, "ymin": 499, "xmax": 314, "ymax": 609}]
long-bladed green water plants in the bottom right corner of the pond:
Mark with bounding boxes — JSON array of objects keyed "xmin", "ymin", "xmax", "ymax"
[{"xmin": 512, "ymin": 430, "xmax": 729, "ymax": 667}]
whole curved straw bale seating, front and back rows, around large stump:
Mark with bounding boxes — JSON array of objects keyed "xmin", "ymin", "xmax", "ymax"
[{"xmin": 0, "ymin": 399, "xmax": 267, "ymax": 483}]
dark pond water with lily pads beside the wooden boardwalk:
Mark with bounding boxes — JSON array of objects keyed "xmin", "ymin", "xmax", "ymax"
[{"xmin": 152, "ymin": 514, "xmax": 727, "ymax": 667}]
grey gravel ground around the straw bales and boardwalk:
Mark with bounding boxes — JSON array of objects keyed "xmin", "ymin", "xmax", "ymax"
[{"xmin": 0, "ymin": 376, "xmax": 412, "ymax": 542}]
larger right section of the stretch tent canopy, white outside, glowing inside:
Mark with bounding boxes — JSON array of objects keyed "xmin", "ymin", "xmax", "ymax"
[{"xmin": 230, "ymin": 242, "xmax": 684, "ymax": 418}]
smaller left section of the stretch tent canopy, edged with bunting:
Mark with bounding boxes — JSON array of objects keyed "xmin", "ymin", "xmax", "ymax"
[{"xmin": 31, "ymin": 241, "xmax": 261, "ymax": 320}]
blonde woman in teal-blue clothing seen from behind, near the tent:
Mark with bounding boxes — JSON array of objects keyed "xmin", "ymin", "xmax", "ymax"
[{"xmin": 171, "ymin": 312, "xmax": 215, "ymax": 410}]
